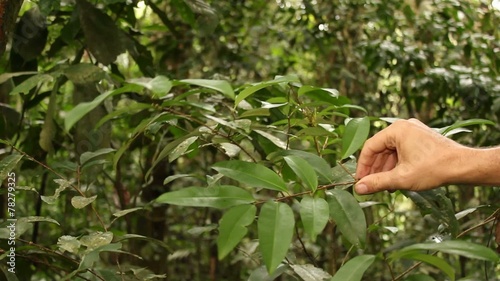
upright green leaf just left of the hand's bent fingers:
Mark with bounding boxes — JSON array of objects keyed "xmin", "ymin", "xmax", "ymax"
[{"xmin": 341, "ymin": 117, "xmax": 370, "ymax": 159}]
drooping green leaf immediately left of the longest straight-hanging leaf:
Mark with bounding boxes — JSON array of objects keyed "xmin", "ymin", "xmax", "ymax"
[{"xmin": 217, "ymin": 205, "xmax": 257, "ymax": 260}]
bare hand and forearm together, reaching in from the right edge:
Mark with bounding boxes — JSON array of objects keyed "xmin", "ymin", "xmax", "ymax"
[{"xmin": 355, "ymin": 119, "xmax": 500, "ymax": 194}]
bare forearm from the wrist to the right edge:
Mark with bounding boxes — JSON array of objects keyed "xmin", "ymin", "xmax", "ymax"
[{"xmin": 447, "ymin": 146, "xmax": 500, "ymax": 186}]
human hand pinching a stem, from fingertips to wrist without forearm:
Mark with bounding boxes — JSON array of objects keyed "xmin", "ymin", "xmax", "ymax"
[{"xmin": 355, "ymin": 119, "xmax": 463, "ymax": 194}]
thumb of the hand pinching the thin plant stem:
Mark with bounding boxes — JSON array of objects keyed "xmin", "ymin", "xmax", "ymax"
[{"xmin": 354, "ymin": 170, "xmax": 398, "ymax": 195}]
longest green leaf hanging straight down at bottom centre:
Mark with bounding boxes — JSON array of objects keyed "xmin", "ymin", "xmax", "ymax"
[{"xmin": 257, "ymin": 201, "xmax": 295, "ymax": 274}]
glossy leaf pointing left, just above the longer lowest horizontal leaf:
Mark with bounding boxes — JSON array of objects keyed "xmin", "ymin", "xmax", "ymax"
[{"xmin": 212, "ymin": 160, "xmax": 288, "ymax": 192}]
